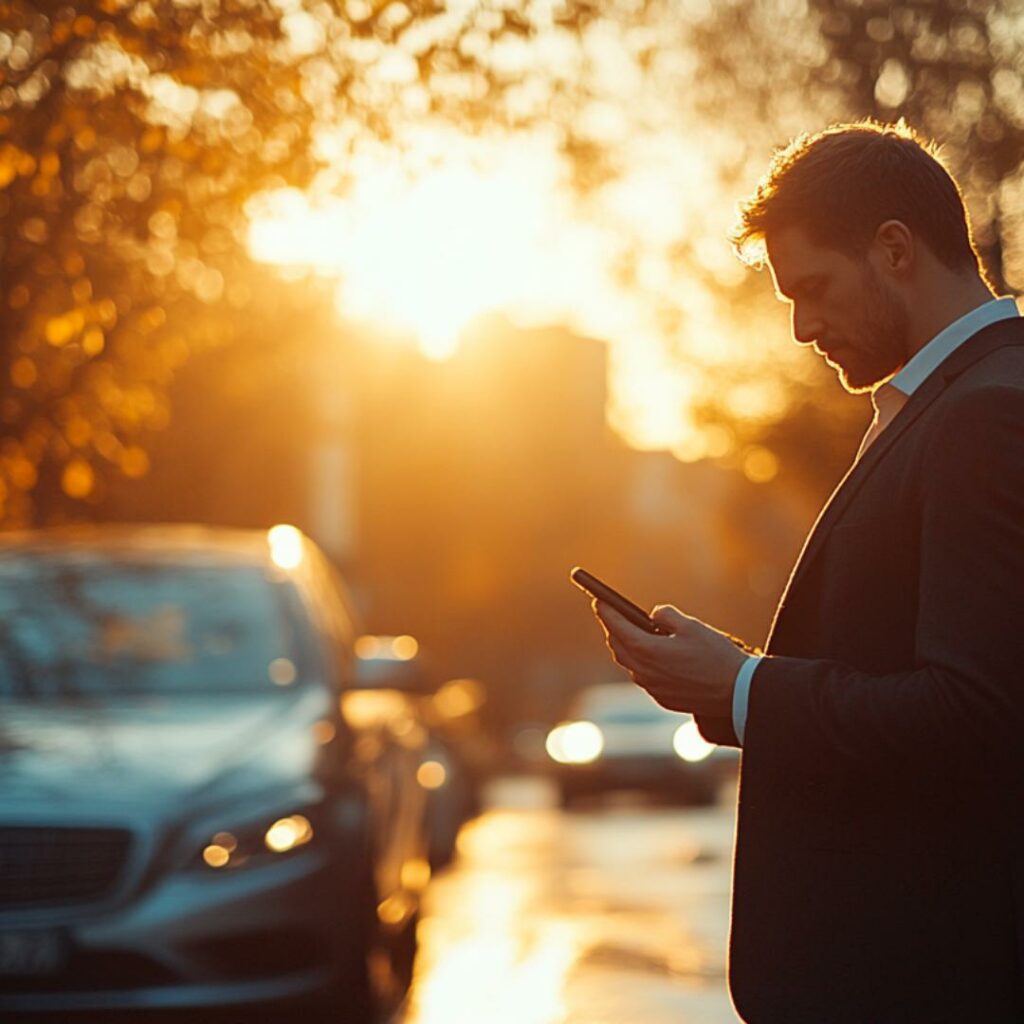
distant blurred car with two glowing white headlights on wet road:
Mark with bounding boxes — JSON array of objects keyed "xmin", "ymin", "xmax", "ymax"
[{"xmin": 546, "ymin": 683, "xmax": 735, "ymax": 807}]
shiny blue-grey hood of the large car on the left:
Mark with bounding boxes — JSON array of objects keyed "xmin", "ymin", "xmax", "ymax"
[{"xmin": 0, "ymin": 687, "xmax": 329, "ymax": 813}]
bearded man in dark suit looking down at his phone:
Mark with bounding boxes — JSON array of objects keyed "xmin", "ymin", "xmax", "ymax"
[{"xmin": 595, "ymin": 123, "xmax": 1024, "ymax": 1024}]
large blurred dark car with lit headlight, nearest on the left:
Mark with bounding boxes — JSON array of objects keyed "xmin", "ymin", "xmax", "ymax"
[{"xmin": 0, "ymin": 526, "xmax": 430, "ymax": 1024}]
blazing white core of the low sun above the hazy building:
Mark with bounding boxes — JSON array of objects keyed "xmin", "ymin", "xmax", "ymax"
[{"xmin": 249, "ymin": 130, "xmax": 569, "ymax": 359}]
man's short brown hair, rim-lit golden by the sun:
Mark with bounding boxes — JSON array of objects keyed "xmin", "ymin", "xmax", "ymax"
[{"xmin": 730, "ymin": 121, "xmax": 980, "ymax": 272}]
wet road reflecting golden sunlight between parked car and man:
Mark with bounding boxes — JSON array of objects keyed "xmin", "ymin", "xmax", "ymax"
[{"xmin": 394, "ymin": 779, "xmax": 738, "ymax": 1024}]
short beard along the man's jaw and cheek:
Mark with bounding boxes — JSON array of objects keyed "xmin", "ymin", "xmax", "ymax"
[{"xmin": 835, "ymin": 266, "xmax": 910, "ymax": 393}]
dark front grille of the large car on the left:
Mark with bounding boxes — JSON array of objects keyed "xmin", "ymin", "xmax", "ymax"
[{"xmin": 0, "ymin": 827, "xmax": 131, "ymax": 908}]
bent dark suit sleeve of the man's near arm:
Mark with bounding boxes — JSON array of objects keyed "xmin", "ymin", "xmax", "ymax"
[{"xmin": 743, "ymin": 386, "xmax": 1024, "ymax": 774}]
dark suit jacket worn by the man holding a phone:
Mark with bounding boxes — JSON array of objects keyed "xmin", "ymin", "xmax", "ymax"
[{"xmin": 699, "ymin": 319, "xmax": 1024, "ymax": 1024}]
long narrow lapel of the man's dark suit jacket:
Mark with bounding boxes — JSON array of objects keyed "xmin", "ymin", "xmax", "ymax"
[{"xmin": 765, "ymin": 318, "xmax": 1021, "ymax": 650}]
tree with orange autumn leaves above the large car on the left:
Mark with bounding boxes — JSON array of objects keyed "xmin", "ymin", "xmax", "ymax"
[{"xmin": 0, "ymin": 0, "xmax": 589, "ymax": 524}]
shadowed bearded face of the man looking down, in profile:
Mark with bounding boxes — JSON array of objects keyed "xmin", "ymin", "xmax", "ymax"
[{"xmin": 766, "ymin": 226, "xmax": 909, "ymax": 391}]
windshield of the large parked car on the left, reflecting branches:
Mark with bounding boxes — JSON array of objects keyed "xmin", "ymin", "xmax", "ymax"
[{"xmin": 0, "ymin": 555, "xmax": 302, "ymax": 697}]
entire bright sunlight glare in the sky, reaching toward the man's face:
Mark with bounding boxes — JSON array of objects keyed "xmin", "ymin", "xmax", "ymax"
[{"xmin": 247, "ymin": 119, "xmax": 799, "ymax": 461}]
